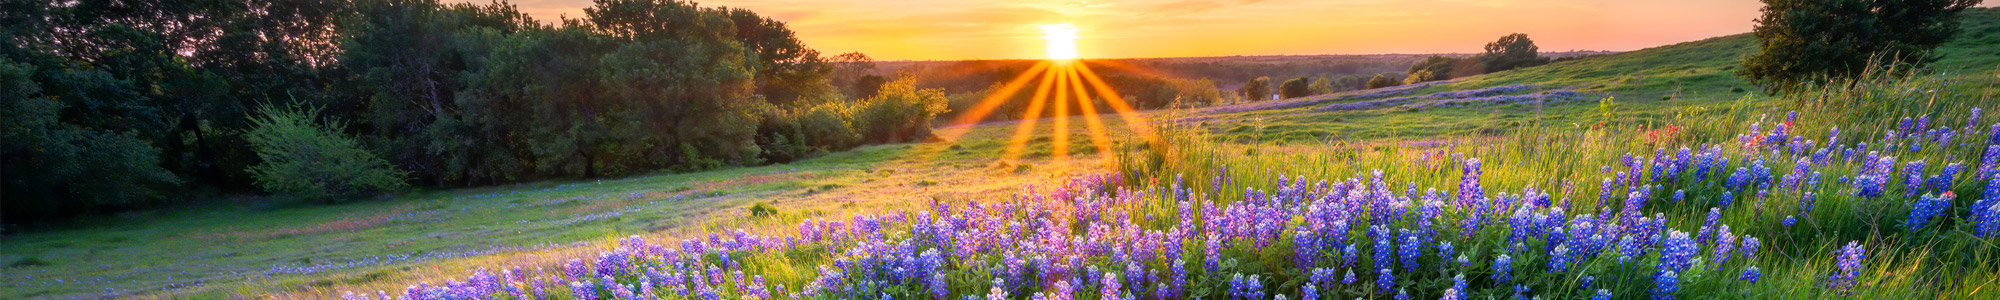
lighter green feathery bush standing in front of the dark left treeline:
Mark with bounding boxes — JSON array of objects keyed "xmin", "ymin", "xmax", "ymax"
[{"xmin": 244, "ymin": 108, "xmax": 404, "ymax": 202}]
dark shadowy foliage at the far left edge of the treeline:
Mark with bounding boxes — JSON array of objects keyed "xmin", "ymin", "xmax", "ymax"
[{"xmin": 0, "ymin": 58, "xmax": 178, "ymax": 222}]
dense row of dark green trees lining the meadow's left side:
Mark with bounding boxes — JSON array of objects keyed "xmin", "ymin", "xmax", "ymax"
[{"xmin": 0, "ymin": 0, "xmax": 946, "ymax": 224}]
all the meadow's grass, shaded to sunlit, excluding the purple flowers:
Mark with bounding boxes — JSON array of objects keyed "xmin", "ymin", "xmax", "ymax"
[{"xmin": 0, "ymin": 8, "xmax": 2000, "ymax": 298}]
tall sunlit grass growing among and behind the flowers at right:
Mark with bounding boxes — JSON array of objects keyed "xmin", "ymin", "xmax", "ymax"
[{"xmin": 1118, "ymin": 66, "xmax": 2000, "ymax": 298}]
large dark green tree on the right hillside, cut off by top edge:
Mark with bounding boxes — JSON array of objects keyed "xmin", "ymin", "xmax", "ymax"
[{"xmin": 1738, "ymin": 0, "xmax": 1980, "ymax": 92}]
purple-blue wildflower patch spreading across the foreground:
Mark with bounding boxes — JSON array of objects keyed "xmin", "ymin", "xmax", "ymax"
[{"xmin": 346, "ymin": 108, "xmax": 2000, "ymax": 300}]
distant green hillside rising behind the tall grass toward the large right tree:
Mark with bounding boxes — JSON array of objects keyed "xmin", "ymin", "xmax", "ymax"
[{"xmin": 1180, "ymin": 8, "xmax": 2000, "ymax": 144}]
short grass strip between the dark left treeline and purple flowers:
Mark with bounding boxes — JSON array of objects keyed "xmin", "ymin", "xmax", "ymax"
[{"xmin": 0, "ymin": 118, "xmax": 1122, "ymax": 298}]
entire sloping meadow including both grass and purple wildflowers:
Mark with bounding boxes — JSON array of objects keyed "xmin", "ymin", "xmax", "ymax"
[{"xmin": 0, "ymin": 10, "xmax": 2000, "ymax": 300}]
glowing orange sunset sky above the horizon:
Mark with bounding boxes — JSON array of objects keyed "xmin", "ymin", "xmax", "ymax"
[{"xmin": 472, "ymin": 0, "xmax": 1992, "ymax": 60}]
